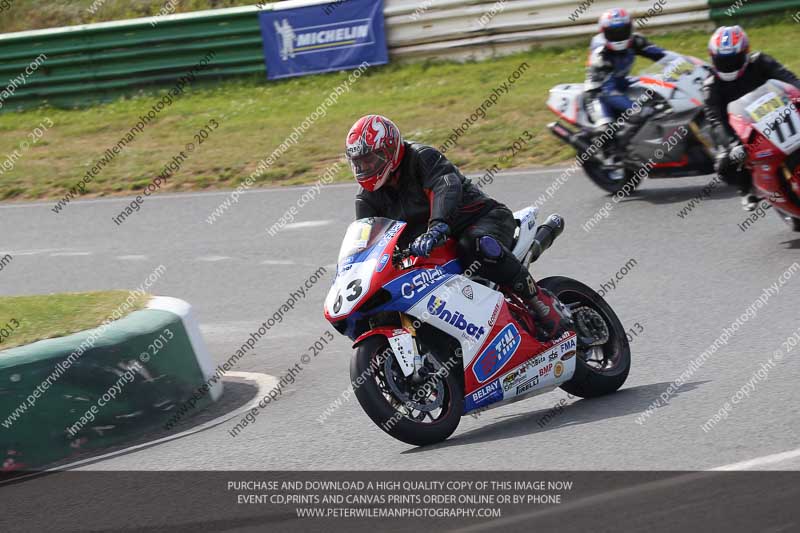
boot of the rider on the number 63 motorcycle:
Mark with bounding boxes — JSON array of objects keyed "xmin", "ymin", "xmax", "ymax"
[{"xmin": 512, "ymin": 268, "xmax": 575, "ymax": 342}]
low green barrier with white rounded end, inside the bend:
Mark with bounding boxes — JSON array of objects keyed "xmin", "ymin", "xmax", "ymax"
[{"xmin": 0, "ymin": 309, "xmax": 213, "ymax": 472}]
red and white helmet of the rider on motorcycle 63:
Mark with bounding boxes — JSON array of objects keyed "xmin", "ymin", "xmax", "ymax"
[{"xmin": 345, "ymin": 115, "xmax": 405, "ymax": 191}]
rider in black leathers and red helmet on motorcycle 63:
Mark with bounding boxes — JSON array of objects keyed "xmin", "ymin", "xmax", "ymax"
[{"xmin": 346, "ymin": 115, "xmax": 572, "ymax": 340}]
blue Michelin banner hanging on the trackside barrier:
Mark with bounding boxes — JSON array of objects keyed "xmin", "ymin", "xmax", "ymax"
[{"xmin": 259, "ymin": 0, "xmax": 389, "ymax": 80}]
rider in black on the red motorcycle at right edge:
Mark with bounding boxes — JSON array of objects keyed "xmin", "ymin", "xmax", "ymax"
[{"xmin": 703, "ymin": 26, "xmax": 800, "ymax": 211}]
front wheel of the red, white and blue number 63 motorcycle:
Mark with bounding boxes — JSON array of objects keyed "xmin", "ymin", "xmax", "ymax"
[{"xmin": 350, "ymin": 336, "xmax": 464, "ymax": 446}]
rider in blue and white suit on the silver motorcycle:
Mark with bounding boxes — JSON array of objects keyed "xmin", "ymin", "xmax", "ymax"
[{"xmin": 584, "ymin": 9, "xmax": 667, "ymax": 150}]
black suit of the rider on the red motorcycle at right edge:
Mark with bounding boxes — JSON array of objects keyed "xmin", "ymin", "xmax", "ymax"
[{"xmin": 703, "ymin": 52, "xmax": 800, "ymax": 192}]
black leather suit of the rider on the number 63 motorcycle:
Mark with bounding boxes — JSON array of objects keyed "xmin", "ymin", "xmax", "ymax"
[{"xmin": 356, "ymin": 141, "xmax": 532, "ymax": 298}]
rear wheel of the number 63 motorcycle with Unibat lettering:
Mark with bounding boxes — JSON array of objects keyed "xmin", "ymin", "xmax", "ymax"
[{"xmin": 539, "ymin": 276, "xmax": 631, "ymax": 398}]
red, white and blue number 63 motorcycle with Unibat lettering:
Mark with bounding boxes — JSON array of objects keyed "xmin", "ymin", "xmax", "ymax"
[{"xmin": 325, "ymin": 207, "xmax": 631, "ymax": 445}]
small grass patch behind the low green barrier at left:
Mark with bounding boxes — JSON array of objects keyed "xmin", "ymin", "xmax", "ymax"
[{"xmin": 0, "ymin": 291, "xmax": 150, "ymax": 350}]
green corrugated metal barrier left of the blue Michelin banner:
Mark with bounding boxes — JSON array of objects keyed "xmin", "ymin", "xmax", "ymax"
[{"xmin": 0, "ymin": 9, "xmax": 266, "ymax": 111}]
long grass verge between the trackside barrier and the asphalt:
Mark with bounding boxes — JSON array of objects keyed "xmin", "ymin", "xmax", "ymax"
[{"xmin": 0, "ymin": 17, "xmax": 800, "ymax": 199}]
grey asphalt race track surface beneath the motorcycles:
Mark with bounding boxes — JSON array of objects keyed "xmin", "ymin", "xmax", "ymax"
[{"xmin": 0, "ymin": 169, "xmax": 800, "ymax": 471}]
